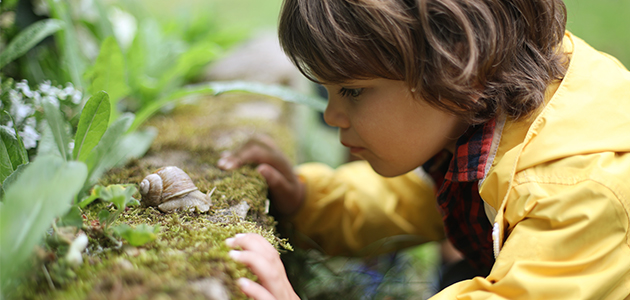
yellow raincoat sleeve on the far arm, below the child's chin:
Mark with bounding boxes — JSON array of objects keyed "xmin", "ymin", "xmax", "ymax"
[{"xmin": 291, "ymin": 161, "xmax": 444, "ymax": 255}]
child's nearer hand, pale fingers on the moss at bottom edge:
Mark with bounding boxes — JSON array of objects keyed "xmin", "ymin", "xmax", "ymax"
[{"xmin": 225, "ymin": 233, "xmax": 300, "ymax": 300}]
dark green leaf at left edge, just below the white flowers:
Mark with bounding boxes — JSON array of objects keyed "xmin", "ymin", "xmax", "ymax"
[{"xmin": 0, "ymin": 111, "xmax": 28, "ymax": 182}]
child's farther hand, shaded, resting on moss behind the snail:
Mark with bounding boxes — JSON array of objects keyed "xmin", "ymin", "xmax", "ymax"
[{"xmin": 217, "ymin": 136, "xmax": 304, "ymax": 215}]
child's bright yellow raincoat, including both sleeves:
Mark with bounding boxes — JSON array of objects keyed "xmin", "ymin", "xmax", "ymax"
[{"xmin": 292, "ymin": 33, "xmax": 630, "ymax": 300}]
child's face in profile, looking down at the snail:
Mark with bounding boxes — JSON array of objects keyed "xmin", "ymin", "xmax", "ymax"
[{"xmin": 324, "ymin": 78, "xmax": 468, "ymax": 177}]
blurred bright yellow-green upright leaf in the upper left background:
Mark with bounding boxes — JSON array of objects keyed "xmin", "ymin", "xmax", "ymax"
[{"xmin": 85, "ymin": 36, "xmax": 129, "ymax": 121}]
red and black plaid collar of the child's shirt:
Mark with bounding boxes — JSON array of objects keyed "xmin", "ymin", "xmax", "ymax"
[{"xmin": 444, "ymin": 119, "xmax": 496, "ymax": 182}]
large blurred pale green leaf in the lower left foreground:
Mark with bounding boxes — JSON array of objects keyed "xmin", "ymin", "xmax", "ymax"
[{"xmin": 0, "ymin": 156, "xmax": 87, "ymax": 290}]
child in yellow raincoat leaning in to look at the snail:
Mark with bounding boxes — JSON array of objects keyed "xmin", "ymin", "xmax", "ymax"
[{"xmin": 219, "ymin": 0, "xmax": 630, "ymax": 299}]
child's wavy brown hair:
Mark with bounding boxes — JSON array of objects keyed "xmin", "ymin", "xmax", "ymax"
[{"xmin": 278, "ymin": 0, "xmax": 567, "ymax": 123}]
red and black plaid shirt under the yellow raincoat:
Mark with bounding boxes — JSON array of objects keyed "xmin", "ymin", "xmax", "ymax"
[{"xmin": 424, "ymin": 120, "xmax": 496, "ymax": 273}]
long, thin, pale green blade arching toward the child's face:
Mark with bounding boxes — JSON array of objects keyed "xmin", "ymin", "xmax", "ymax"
[{"xmin": 129, "ymin": 81, "xmax": 326, "ymax": 131}]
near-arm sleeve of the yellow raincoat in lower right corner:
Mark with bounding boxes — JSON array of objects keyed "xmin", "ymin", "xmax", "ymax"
[{"xmin": 431, "ymin": 177, "xmax": 630, "ymax": 300}]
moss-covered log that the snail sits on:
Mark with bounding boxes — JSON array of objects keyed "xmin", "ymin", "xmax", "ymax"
[{"xmin": 17, "ymin": 93, "xmax": 295, "ymax": 300}]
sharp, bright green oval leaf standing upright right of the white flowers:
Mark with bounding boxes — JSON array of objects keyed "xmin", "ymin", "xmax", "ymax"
[{"xmin": 72, "ymin": 91, "xmax": 111, "ymax": 161}]
